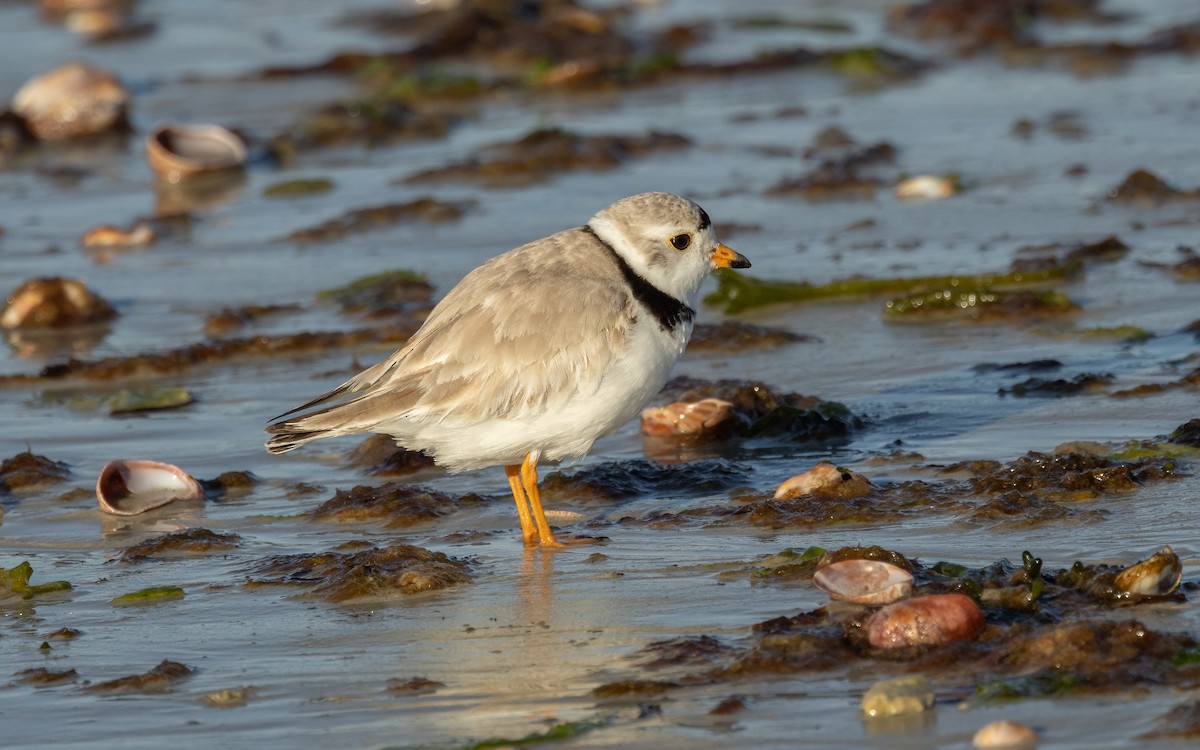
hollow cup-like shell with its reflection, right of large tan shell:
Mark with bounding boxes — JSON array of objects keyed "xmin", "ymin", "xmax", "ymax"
[{"xmin": 146, "ymin": 125, "xmax": 246, "ymax": 182}]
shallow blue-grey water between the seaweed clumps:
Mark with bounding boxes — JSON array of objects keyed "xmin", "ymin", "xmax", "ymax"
[{"xmin": 0, "ymin": 1, "xmax": 1200, "ymax": 748}]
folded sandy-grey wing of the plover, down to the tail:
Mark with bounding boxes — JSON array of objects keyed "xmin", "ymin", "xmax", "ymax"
[{"xmin": 268, "ymin": 229, "xmax": 635, "ymax": 452}]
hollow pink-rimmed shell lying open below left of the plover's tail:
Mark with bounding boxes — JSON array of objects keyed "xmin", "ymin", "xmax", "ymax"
[{"xmin": 96, "ymin": 461, "xmax": 204, "ymax": 516}]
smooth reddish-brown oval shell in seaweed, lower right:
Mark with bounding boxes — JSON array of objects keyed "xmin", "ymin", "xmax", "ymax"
[{"xmin": 863, "ymin": 594, "xmax": 986, "ymax": 649}]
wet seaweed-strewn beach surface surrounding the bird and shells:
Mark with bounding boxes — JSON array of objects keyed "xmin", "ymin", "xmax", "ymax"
[{"xmin": 0, "ymin": 0, "xmax": 1200, "ymax": 748}]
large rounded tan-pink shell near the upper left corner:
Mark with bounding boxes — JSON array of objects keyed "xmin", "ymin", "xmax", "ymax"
[{"xmin": 12, "ymin": 62, "xmax": 130, "ymax": 140}]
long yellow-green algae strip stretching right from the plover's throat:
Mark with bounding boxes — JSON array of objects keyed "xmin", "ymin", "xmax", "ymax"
[{"xmin": 704, "ymin": 263, "xmax": 1082, "ymax": 313}]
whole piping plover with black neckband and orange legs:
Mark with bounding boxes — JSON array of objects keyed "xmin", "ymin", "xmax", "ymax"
[{"xmin": 266, "ymin": 193, "xmax": 750, "ymax": 547}]
